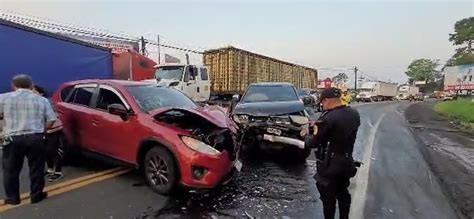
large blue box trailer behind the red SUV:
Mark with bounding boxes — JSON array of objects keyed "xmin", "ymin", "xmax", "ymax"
[{"xmin": 0, "ymin": 19, "xmax": 112, "ymax": 95}]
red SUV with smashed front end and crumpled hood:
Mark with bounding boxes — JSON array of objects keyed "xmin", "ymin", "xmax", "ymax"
[{"xmin": 53, "ymin": 80, "xmax": 241, "ymax": 194}]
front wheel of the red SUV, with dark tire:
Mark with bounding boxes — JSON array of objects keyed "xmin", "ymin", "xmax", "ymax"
[{"xmin": 143, "ymin": 146, "xmax": 179, "ymax": 195}]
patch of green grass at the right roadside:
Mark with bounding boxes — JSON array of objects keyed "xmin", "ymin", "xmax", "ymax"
[{"xmin": 434, "ymin": 98, "xmax": 474, "ymax": 131}]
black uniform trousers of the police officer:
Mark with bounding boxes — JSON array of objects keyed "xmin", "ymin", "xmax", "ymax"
[{"xmin": 316, "ymin": 176, "xmax": 351, "ymax": 219}]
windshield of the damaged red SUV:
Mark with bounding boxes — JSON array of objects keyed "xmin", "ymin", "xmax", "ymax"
[{"xmin": 127, "ymin": 85, "xmax": 196, "ymax": 112}]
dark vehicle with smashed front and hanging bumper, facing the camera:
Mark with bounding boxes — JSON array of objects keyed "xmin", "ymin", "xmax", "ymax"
[{"xmin": 232, "ymin": 83, "xmax": 311, "ymax": 161}]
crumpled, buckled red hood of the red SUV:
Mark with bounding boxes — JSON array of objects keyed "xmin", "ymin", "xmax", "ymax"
[{"xmin": 150, "ymin": 106, "xmax": 232, "ymax": 128}]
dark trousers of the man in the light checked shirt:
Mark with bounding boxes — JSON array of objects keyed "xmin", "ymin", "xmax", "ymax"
[{"xmin": 2, "ymin": 134, "xmax": 46, "ymax": 202}]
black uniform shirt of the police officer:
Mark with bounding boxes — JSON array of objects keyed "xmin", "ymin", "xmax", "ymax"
[{"xmin": 311, "ymin": 106, "xmax": 360, "ymax": 156}]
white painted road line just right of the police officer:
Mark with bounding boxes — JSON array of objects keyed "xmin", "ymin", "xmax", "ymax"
[{"xmin": 349, "ymin": 113, "xmax": 385, "ymax": 219}]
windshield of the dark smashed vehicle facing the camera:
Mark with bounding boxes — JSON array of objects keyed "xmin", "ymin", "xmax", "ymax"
[{"xmin": 242, "ymin": 85, "xmax": 298, "ymax": 103}]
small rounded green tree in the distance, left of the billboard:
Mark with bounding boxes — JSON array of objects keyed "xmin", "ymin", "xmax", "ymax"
[{"xmin": 405, "ymin": 59, "xmax": 441, "ymax": 83}]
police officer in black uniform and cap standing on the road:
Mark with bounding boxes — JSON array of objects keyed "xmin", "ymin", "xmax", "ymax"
[{"xmin": 308, "ymin": 88, "xmax": 360, "ymax": 219}]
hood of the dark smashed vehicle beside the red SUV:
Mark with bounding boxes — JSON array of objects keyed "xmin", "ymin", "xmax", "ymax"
[{"xmin": 233, "ymin": 101, "xmax": 305, "ymax": 116}]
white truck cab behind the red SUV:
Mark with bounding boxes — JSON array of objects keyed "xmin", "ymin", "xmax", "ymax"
[{"xmin": 147, "ymin": 64, "xmax": 211, "ymax": 102}]
